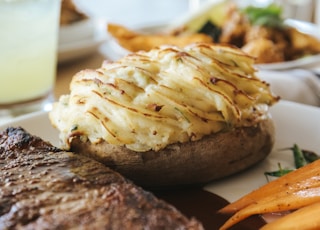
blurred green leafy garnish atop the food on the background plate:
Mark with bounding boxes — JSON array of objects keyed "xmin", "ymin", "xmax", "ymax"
[{"xmin": 242, "ymin": 4, "xmax": 283, "ymax": 27}]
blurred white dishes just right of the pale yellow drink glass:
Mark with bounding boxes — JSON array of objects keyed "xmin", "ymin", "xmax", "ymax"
[{"xmin": 58, "ymin": 19, "xmax": 108, "ymax": 63}]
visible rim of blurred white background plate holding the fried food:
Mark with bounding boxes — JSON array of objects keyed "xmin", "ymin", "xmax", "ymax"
[{"xmin": 103, "ymin": 19, "xmax": 320, "ymax": 70}]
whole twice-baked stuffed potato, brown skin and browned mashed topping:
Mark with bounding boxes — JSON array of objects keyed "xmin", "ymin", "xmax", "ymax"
[{"xmin": 49, "ymin": 43, "xmax": 279, "ymax": 187}]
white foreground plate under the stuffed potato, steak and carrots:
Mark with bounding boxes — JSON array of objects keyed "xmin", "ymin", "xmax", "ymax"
[{"xmin": 0, "ymin": 101, "xmax": 320, "ymax": 202}]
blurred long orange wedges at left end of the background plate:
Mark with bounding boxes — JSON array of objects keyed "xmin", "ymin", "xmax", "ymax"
[{"xmin": 108, "ymin": 23, "xmax": 212, "ymax": 52}]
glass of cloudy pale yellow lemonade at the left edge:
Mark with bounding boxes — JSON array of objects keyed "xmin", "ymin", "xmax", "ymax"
[{"xmin": 0, "ymin": 0, "xmax": 61, "ymax": 122}]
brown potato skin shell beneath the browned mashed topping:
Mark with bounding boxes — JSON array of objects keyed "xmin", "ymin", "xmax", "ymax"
[{"xmin": 71, "ymin": 118, "xmax": 275, "ymax": 188}]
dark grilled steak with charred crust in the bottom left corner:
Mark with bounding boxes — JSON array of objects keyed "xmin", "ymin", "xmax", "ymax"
[{"xmin": 0, "ymin": 128, "xmax": 203, "ymax": 229}]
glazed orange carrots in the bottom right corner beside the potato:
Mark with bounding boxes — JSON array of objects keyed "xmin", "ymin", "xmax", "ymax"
[{"xmin": 220, "ymin": 157, "xmax": 320, "ymax": 230}]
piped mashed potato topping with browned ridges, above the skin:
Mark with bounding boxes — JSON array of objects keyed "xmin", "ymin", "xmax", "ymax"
[{"xmin": 50, "ymin": 43, "xmax": 278, "ymax": 151}]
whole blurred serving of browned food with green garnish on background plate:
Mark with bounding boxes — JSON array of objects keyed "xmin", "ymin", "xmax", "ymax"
[{"xmin": 108, "ymin": 3, "xmax": 320, "ymax": 64}]
